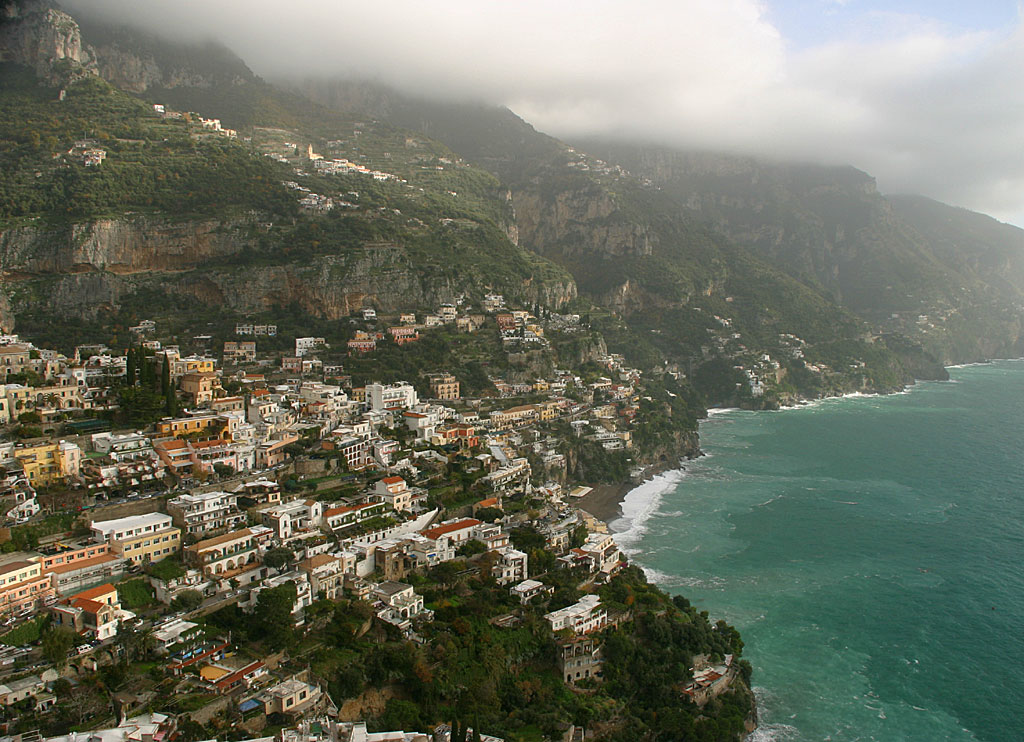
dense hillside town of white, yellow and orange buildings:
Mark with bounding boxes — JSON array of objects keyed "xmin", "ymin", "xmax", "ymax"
[{"xmin": 0, "ymin": 294, "xmax": 735, "ymax": 742}]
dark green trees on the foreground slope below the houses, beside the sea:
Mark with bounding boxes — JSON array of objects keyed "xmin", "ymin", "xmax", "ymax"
[{"xmin": 208, "ymin": 564, "xmax": 752, "ymax": 742}]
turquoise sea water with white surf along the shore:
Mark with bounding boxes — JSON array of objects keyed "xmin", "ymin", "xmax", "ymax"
[{"xmin": 612, "ymin": 361, "xmax": 1024, "ymax": 742}]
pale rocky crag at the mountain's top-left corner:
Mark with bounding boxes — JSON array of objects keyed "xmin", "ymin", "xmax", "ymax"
[{"xmin": 0, "ymin": 0, "xmax": 96, "ymax": 85}]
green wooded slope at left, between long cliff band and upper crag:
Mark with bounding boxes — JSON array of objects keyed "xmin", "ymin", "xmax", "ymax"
[{"xmin": 0, "ymin": 62, "xmax": 296, "ymax": 219}]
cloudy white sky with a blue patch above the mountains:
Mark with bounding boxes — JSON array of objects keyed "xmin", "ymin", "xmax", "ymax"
[{"xmin": 63, "ymin": 0, "xmax": 1024, "ymax": 226}]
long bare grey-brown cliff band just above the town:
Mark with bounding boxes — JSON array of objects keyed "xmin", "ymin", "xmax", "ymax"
[{"xmin": 0, "ymin": 216, "xmax": 575, "ymax": 319}]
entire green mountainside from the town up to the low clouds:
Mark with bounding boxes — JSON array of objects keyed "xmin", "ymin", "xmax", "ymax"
[{"xmin": 8, "ymin": 5, "xmax": 1024, "ymax": 405}]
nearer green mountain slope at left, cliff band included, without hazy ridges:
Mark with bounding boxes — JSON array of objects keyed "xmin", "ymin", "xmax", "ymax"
[{"xmin": 0, "ymin": 5, "xmax": 575, "ymax": 347}]
